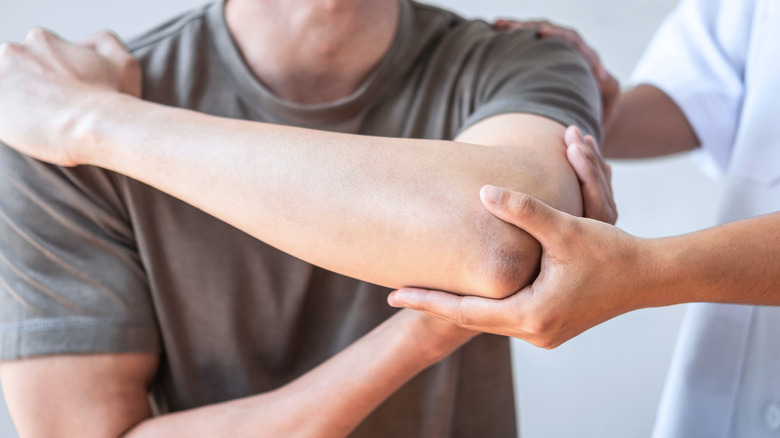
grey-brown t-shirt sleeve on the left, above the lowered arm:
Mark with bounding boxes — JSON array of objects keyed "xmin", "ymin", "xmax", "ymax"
[{"xmin": 0, "ymin": 144, "xmax": 159, "ymax": 360}]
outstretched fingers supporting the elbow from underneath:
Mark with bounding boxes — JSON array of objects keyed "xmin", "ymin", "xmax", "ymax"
[{"xmin": 387, "ymin": 288, "xmax": 522, "ymax": 336}]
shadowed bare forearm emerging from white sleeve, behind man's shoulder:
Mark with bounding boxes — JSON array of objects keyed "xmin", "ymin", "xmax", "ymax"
[{"xmin": 602, "ymin": 85, "xmax": 699, "ymax": 158}]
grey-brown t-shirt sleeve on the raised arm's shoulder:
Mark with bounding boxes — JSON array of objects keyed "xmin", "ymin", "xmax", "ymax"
[{"xmin": 460, "ymin": 30, "xmax": 601, "ymax": 139}]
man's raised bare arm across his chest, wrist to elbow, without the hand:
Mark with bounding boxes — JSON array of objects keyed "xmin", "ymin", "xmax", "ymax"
[{"xmin": 76, "ymin": 92, "xmax": 581, "ymax": 296}]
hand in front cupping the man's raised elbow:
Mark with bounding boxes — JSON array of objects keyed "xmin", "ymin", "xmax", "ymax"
[{"xmin": 388, "ymin": 186, "xmax": 653, "ymax": 348}]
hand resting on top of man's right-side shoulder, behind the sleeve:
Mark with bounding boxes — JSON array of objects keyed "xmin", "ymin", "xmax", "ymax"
[{"xmin": 493, "ymin": 20, "xmax": 620, "ymax": 127}]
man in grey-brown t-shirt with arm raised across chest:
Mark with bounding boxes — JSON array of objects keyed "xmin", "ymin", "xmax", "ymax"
[{"xmin": 0, "ymin": 0, "xmax": 599, "ymax": 437}]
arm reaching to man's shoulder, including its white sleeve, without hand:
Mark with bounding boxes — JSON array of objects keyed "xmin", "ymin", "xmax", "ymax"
[{"xmin": 620, "ymin": 0, "xmax": 758, "ymax": 163}]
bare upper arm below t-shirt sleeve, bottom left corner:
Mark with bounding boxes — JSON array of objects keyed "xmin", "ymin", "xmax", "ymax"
[{"xmin": 0, "ymin": 353, "xmax": 158, "ymax": 437}]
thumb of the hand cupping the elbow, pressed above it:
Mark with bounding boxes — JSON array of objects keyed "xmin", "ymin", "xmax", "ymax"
[{"xmin": 480, "ymin": 185, "xmax": 568, "ymax": 246}]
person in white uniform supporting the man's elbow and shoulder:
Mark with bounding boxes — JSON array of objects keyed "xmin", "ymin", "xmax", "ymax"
[{"xmin": 390, "ymin": 0, "xmax": 780, "ymax": 438}]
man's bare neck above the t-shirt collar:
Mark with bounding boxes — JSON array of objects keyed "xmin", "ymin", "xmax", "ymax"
[{"xmin": 225, "ymin": 0, "xmax": 399, "ymax": 104}]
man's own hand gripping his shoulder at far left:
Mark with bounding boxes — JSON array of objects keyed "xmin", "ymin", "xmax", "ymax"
[{"xmin": 0, "ymin": 29, "xmax": 141, "ymax": 166}]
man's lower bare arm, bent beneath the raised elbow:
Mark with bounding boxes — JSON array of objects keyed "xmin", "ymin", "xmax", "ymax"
[{"xmin": 0, "ymin": 311, "xmax": 473, "ymax": 438}]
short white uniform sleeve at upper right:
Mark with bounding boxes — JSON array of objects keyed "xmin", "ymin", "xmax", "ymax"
[{"xmin": 630, "ymin": 0, "xmax": 754, "ymax": 174}]
